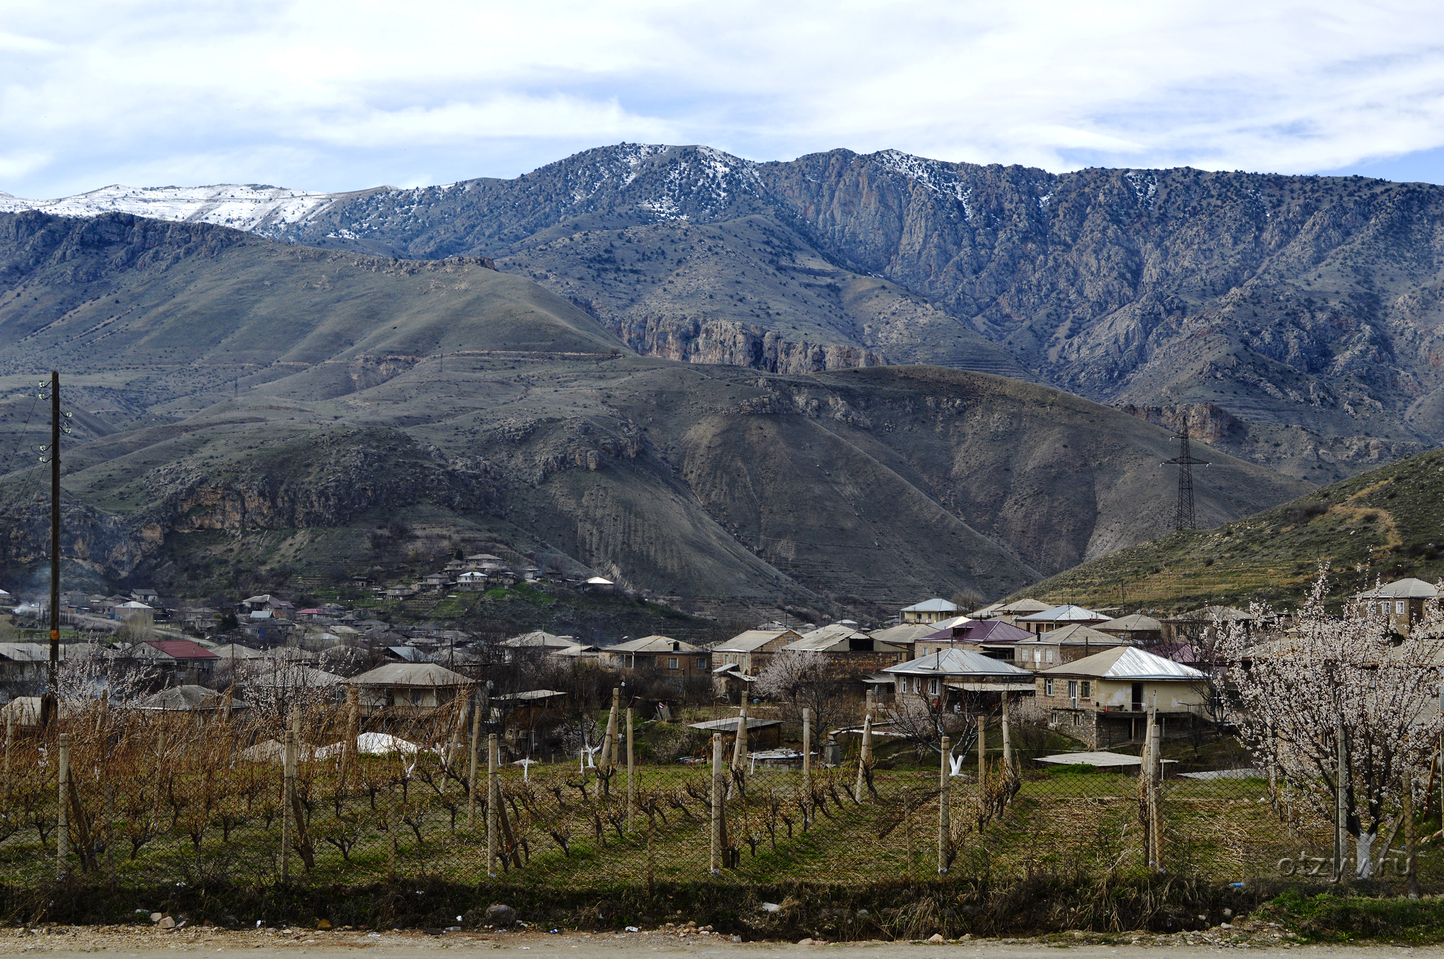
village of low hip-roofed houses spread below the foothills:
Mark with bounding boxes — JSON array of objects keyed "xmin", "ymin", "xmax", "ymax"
[{"xmin": 0, "ymin": 545, "xmax": 1438, "ymax": 760}]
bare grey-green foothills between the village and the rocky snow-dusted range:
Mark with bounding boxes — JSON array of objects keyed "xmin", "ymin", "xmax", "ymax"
[{"xmin": 0, "ymin": 212, "xmax": 1308, "ymax": 611}]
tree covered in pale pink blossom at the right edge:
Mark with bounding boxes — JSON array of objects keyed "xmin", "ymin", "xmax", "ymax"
[{"xmin": 1220, "ymin": 569, "xmax": 1444, "ymax": 878}]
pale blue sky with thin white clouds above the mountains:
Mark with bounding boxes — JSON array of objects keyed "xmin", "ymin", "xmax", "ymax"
[{"xmin": 0, "ymin": 0, "xmax": 1444, "ymax": 199}]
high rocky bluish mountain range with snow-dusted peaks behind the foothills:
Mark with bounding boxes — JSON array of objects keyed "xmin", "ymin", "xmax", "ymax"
[{"xmin": 11, "ymin": 143, "xmax": 1444, "ymax": 484}]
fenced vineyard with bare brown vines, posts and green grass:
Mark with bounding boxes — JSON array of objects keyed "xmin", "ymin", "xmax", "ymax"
[{"xmin": 0, "ymin": 684, "xmax": 1444, "ymax": 891}]
